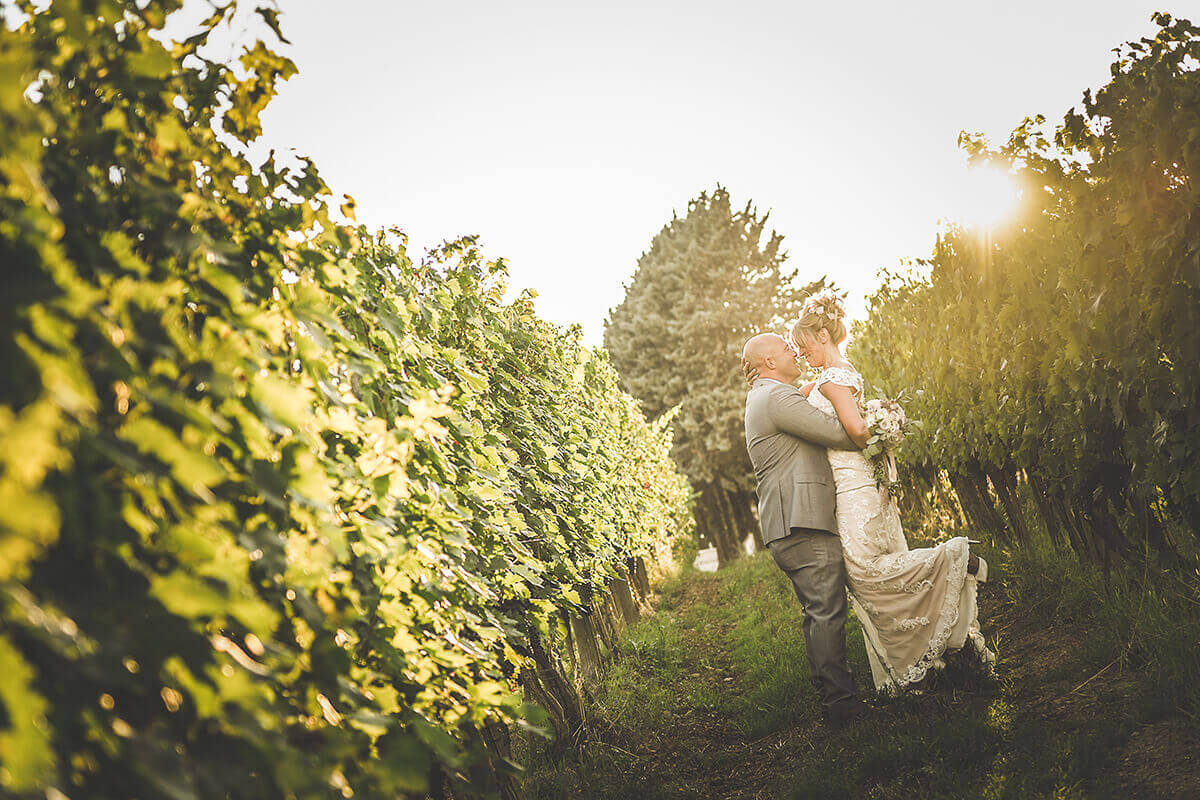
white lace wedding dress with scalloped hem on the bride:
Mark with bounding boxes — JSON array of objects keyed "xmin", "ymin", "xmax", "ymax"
[{"xmin": 809, "ymin": 367, "xmax": 996, "ymax": 693}]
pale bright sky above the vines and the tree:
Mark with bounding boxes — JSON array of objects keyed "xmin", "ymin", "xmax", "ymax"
[{"xmin": 229, "ymin": 0, "xmax": 1176, "ymax": 344}]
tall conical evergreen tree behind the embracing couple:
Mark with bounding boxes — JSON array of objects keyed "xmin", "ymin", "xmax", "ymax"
[{"xmin": 605, "ymin": 186, "xmax": 824, "ymax": 564}]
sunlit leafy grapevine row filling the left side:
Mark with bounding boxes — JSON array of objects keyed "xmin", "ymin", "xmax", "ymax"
[{"xmin": 0, "ymin": 0, "xmax": 691, "ymax": 798}]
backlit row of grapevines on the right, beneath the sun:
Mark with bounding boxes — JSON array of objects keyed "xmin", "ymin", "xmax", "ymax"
[{"xmin": 853, "ymin": 13, "xmax": 1200, "ymax": 563}]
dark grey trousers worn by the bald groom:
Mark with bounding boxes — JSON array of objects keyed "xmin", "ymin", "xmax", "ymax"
[{"xmin": 767, "ymin": 528, "xmax": 856, "ymax": 709}]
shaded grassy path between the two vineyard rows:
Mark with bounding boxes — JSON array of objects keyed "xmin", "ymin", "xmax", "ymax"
[{"xmin": 526, "ymin": 554, "xmax": 1200, "ymax": 800}]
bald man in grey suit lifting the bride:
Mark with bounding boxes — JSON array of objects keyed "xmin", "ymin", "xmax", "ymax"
[{"xmin": 742, "ymin": 333, "xmax": 864, "ymax": 726}]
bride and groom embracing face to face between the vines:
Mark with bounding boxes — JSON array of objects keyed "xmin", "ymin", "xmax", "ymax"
[{"xmin": 742, "ymin": 289, "xmax": 996, "ymax": 724}]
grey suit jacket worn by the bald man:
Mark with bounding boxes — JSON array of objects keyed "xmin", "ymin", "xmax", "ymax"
[{"xmin": 746, "ymin": 378, "xmax": 857, "ymax": 545}]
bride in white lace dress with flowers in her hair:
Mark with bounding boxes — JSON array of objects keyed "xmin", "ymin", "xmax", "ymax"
[{"xmin": 792, "ymin": 289, "xmax": 996, "ymax": 693}]
